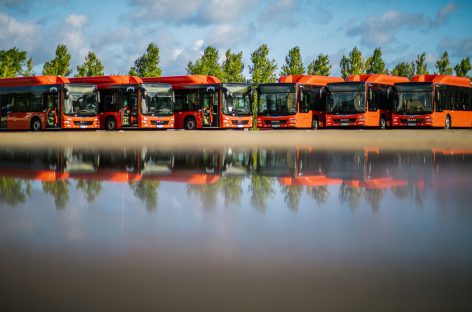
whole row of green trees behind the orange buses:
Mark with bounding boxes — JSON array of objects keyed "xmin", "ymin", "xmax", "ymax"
[{"xmin": 0, "ymin": 43, "xmax": 472, "ymax": 81}]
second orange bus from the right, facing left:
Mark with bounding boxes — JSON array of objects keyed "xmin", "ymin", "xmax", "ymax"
[{"xmin": 326, "ymin": 74, "xmax": 408, "ymax": 129}]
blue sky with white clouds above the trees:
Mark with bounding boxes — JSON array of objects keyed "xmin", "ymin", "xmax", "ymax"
[{"xmin": 0, "ymin": 0, "xmax": 472, "ymax": 76}]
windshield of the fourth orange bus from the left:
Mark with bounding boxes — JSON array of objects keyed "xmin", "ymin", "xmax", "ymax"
[{"xmin": 259, "ymin": 84, "xmax": 297, "ymax": 115}]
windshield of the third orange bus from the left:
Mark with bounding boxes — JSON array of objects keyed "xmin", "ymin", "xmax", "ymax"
[{"xmin": 223, "ymin": 84, "xmax": 252, "ymax": 116}]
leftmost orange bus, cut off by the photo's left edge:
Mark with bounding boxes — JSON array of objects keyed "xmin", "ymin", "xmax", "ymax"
[{"xmin": 0, "ymin": 76, "xmax": 100, "ymax": 131}]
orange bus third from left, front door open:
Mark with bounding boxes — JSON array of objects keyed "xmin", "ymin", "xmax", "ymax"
[{"xmin": 142, "ymin": 75, "xmax": 252, "ymax": 130}]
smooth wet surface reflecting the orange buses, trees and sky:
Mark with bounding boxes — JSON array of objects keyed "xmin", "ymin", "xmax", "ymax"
[{"xmin": 0, "ymin": 147, "xmax": 472, "ymax": 311}]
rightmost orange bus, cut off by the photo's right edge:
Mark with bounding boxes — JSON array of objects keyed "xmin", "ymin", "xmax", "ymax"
[{"xmin": 392, "ymin": 75, "xmax": 472, "ymax": 128}]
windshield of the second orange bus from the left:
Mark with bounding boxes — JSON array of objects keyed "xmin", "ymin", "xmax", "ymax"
[{"xmin": 141, "ymin": 85, "xmax": 174, "ymax": 116}]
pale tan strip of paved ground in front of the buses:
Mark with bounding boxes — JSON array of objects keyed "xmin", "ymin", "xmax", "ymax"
[{"xmin": 0, "ymin": 129, "xmax": 472, "ymax": 150}]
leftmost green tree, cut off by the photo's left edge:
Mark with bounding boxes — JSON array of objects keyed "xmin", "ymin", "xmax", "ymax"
[{"xmin": 0, "ymin": 47, "xmax": 33, "ymax": 78}]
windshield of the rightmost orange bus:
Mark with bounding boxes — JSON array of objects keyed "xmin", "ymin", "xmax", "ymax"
[{"xmin": 394, "ymin": 85, "xmax": 433, "ymax": 114}]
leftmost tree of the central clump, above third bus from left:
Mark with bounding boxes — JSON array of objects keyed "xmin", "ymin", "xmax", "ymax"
[{"xmin": 187, "ymin": 46, "xmax": 224, "ymax": 80}]
